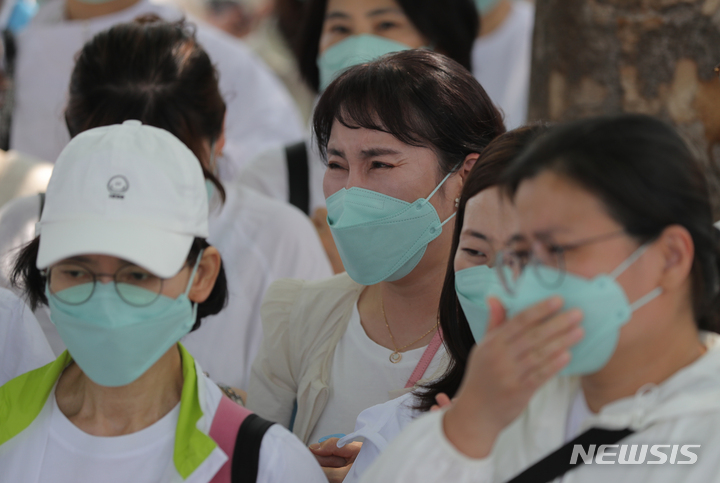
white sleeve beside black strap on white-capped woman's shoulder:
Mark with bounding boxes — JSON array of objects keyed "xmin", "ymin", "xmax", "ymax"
[{"xmin": 257, "ymin": 424, "xmax": 327, "ymax": 483}]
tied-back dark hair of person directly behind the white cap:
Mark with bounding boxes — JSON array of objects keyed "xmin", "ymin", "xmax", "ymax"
[{"xmin": 65, "ymin": 15, "xmax": 225, "ymax": 200}]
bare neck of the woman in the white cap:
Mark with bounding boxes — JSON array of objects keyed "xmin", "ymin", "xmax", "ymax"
[{"xmin": 55, "ymin": 344, "xmax": 183, "ymax": 436}]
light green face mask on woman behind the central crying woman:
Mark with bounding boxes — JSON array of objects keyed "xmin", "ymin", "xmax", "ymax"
[{"xmin": 317, "ymin": 34, "xmax": 410, "ymax": 91}]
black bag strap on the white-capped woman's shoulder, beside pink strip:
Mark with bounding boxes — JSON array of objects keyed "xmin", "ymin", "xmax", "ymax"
[{"xmin": 230, "ymin": 414, "xmax": 275, "ymax": 483}]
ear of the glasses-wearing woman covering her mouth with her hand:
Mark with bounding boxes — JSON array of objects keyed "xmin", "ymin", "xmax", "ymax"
[{"xmin": 656, "ymin": 225, "xmax": 695, "ymax": 291}]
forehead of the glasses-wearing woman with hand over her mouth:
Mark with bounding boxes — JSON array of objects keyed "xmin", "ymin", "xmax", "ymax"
[{"xmin": 515, "ymin": 171, "xmax": 613, "ymax": 235}]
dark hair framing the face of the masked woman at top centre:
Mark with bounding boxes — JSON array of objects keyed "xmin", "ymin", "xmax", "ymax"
[{"xmin": 295, "ymin": 0, "xmax": 480, "ymax": 92}]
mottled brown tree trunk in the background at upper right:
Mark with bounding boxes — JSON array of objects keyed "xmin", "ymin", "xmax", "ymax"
[{"xmin": 529, "ymin": 0, "xmax": 720, "ymax": 214}]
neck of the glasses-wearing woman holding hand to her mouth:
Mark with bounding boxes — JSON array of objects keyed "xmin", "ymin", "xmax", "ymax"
[{"xmin": 581, "ymin": 314, "xmax": 706, "ymax": 413}]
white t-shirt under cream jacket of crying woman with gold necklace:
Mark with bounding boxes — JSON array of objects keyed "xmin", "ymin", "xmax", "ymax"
[{"xmin": 309, "ymin": 305, "xmax": 445, "ymax": 443}]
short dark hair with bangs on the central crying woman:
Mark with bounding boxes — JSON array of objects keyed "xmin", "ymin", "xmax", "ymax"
[{"xmin": 313, "ymin": 50, "xmax": 505, "ymax": 182}]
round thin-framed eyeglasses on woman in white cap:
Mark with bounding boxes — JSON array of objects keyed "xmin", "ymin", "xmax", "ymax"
[{"xmin": 46, "ymin": 262, "xmax": 163, "ymax": 307}]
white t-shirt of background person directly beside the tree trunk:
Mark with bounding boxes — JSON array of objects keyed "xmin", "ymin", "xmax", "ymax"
[{"xmin": 472, "ymin": 0, "xmax": 535, "ymax": 130}]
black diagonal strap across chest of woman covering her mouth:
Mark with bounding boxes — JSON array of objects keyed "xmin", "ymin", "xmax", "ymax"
[{"xmin": 507, "ymin": 428, "xmax": 634, "ymax": 483}]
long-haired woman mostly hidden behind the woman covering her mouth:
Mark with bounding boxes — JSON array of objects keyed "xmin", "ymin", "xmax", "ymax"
[{"xmin": 310, "ymin": 125, "xmax": 547, "ymax": 483}]
